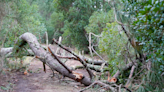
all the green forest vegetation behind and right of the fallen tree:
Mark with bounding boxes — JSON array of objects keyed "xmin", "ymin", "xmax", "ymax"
[{"xmin": 0, "ymin": 0, "xmax": 164, "ymax": 92}]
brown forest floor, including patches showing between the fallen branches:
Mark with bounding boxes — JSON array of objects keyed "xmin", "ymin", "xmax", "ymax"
[{"xmin": 0, "ymin": 45, "xmax": 105, "ymax": 92}]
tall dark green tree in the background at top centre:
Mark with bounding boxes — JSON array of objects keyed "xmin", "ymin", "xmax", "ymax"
[{"xmin": 54, "ymin": 0, "xmax": 110, "ymax": 51}]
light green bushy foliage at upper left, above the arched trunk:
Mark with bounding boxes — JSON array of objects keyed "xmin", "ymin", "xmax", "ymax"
[{"xmin": 1, "ymin": 0, "xmax": 46, "ymax": 46}]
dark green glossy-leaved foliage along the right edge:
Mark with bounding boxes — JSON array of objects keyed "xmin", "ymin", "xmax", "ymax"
[{"xmin": 120, "ymin": 0, "xmax": 164, "ymax": 92}]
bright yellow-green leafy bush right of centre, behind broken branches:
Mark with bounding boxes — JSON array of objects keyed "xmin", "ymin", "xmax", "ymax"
[{"xmin": 99, "ymin": 22, "xmax": 127, "ymax": 74}]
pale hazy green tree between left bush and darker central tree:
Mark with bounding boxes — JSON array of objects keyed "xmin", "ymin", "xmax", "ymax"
[{"xmin": 33, "ymin": 0, "xmax": 55, "ymax": 42}]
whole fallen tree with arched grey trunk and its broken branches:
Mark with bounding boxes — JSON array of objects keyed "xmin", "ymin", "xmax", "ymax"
[{"xmin": 0, "ymin": 32, "xmax": 134, "ymax": 90}]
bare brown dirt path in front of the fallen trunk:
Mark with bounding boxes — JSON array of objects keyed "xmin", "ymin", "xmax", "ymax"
[{"xmin": 0, "ymin": 56, "xmax": 94, "ymax": 92}]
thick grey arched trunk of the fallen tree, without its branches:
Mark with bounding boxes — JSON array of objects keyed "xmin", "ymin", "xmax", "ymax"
[{"xmin": 1, "ymin": 32, "xmax": 92, "ymax": 86}]
